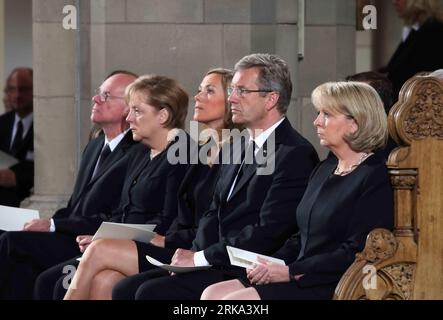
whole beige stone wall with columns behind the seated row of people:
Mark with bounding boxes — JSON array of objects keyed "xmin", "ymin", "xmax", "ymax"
[{"xmin": 29, "ymin": 0, "xmax": 355, "ymax": 213}]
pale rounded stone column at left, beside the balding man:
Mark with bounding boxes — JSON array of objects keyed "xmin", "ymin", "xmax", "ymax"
[{"xmin": 21, "ymin": 0, "xmax": 90, "ymax": 217}]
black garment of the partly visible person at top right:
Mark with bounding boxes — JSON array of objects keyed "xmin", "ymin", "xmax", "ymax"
[{"xmin": 382, "ymin": 18, "xmax": 443, "ymax": 97}]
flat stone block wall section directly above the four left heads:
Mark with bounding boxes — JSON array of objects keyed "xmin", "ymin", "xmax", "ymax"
[{"xmin": 86, "ymin": 0, "xmax": 297, "ymax": 130}]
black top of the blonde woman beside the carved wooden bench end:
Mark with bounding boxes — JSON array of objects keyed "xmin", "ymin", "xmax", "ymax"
[{"xmin": 275, "ymin": 153, "xmax": 394, "ymax": 287}]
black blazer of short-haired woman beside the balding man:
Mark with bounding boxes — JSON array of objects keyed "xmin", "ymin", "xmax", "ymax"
[{"xmin": 108, "ymin": 135, "xmax": 189, "ymax": 235}]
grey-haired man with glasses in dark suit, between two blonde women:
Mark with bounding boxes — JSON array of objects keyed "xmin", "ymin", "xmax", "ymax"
[{"xmin": 122, "ymin": 54, "xmax": 318, "ymax": 300}]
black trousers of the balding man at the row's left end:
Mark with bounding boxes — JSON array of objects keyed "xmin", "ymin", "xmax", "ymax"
[{"xmin": 0, "ymin": 231, "xmax": 79, "ymax": 299}]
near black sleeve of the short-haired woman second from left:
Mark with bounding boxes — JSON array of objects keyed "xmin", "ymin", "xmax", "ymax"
[{"xmin": 154, "ymin": 164, "xmax": 188, "ymax": 235}]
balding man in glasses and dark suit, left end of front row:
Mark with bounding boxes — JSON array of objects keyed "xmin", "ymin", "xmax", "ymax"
[{"xmin": 0, "ymin": 73, "xmax": 136, "ymax": 299}]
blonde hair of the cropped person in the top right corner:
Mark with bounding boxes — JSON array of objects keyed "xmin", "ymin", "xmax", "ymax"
[{"xmin": 401, "ymin": 0, "xmax": 441, "ymax": 25}]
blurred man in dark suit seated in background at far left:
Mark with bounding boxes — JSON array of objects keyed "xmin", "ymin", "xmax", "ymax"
[{"xmin": 0, "ymin": 68, "xmax": 34, "ymax": 207}]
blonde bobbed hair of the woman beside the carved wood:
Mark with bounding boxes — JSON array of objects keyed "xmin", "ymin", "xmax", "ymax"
[{"xmin": 311, "ymin": 81, "xmax": 388, "ymax": 152}]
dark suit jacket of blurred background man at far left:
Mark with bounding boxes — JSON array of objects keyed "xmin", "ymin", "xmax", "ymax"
[{"xmin": 0, "ymin": 111, "xmax": 34, "ymax": 207}]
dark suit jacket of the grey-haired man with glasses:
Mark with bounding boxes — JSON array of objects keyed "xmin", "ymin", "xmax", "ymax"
[{"xmin": 193, "ymin": 119, "xmax": 318, "ymax": 266}]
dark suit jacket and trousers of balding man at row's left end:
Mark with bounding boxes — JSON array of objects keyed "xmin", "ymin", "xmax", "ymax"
[{"xmin": 0, "ymin": 132, "xmax": 138, "ymax": 299}]
